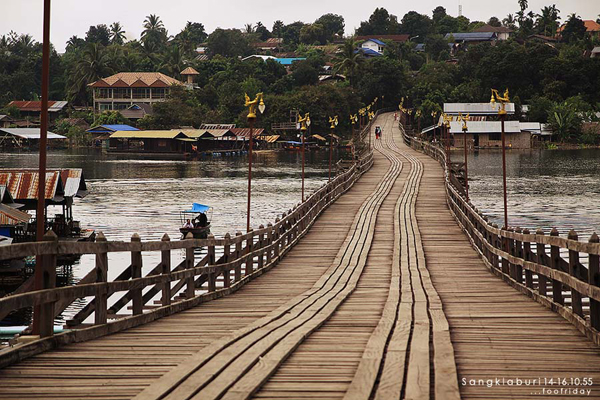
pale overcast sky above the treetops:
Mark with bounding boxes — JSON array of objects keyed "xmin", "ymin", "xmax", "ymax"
[{"xmin": 0, "ymin": 0, "xmax": 600, "ymax": 52}]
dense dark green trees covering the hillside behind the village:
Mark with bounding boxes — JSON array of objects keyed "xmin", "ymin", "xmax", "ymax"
[{"xmin": 0, "ymin": 0, "xmax": 600, "ymax": 141}]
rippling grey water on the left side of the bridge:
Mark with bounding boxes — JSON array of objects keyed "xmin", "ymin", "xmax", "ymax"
[{"xmin": 0, "ymin": 149, "xmax": 338, "ymax": 324}]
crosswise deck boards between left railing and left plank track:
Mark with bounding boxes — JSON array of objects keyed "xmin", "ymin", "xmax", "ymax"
[{"xmin": 0, "ymin": 149, "xmax": 387, "ymax": 399}]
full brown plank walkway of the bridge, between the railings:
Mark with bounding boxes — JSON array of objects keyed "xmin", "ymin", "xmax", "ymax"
[{"xmin": 0, "ymin": 114, "xmax": 600, "ymax": 400}]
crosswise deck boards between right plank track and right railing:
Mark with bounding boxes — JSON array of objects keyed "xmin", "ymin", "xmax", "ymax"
[{"xmin": 414, "ymin": 139, "xmax": 600, "ymax": 399}]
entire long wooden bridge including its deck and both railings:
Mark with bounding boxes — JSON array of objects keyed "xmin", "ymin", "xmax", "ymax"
[{"xmin": 0, "ymin": 114, "xmax": 600, "ymax": 400}]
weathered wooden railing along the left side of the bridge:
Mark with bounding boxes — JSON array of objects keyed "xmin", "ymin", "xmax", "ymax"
[{"xmin": 0, "ymin": 148, "xmax": 373, "ymax": 368}]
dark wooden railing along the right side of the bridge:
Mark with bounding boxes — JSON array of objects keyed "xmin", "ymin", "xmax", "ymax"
[{"xmin": 401, "ymin": 127, "xmax": 600, "ymax": 345}]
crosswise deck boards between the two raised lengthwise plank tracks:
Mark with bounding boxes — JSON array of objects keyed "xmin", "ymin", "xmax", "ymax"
[{"xmin": 253, "ymin": 118, "xmax": 410, "ymax": 399}]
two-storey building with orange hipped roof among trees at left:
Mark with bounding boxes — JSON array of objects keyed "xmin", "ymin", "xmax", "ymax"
[{"xmin": 88, "ymin": 72, "xmax": 183, "ymax": 112}]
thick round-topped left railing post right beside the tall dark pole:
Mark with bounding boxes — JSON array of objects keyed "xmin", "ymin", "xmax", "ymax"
[{"xmin": 33, "ymin": 230, "xmax": 58, "ymax": 338}]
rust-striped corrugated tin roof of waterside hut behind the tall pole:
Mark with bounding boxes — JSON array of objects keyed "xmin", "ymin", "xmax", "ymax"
[{"xmin": 0, "ymin": 168, "xmax": 87, "ymax": 202}]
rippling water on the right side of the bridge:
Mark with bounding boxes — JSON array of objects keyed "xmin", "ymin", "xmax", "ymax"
[{"xmin": 452, "ymin": 149, "xmax": 600, "ymax": 241}]
